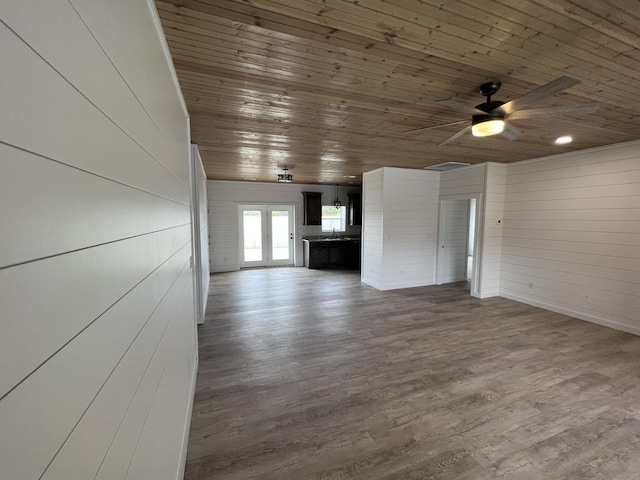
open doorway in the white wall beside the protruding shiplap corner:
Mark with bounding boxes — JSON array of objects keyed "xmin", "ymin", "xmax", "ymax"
[{"xmin": 436, "ymin": 197, "xmax": 479, "ymax": 296}]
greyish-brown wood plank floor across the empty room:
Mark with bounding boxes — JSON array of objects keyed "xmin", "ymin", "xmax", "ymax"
[{"xmin": 185, "ymin": 268, "xmax": 640, "ymax": 480}]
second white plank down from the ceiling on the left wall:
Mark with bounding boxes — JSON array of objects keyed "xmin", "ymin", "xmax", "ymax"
[{"xmin": 0, "ymin": 0, "xmax": 188, "ymax": 187}]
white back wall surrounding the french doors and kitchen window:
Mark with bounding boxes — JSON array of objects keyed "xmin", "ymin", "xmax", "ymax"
[{"xmin": 207, "ymin": 180, "xmax": 361, "ymax": 272}]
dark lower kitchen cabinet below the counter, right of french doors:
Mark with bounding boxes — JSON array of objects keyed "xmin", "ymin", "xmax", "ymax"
[{"xmin": 304, "ymin": 240, "xmax": 360, "ymax": 269}]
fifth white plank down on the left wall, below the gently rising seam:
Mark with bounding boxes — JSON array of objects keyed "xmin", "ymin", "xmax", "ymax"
[{"xmin": 0, "ymin": 226, "xmax": 190, "ymax": 406}]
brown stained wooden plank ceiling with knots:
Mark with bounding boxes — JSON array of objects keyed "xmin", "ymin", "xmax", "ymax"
[{"xmin": 156, "ymin": 0, "xmax": 640, "ymax": 184}]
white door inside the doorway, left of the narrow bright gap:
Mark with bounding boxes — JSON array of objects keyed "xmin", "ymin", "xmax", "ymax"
[{"xmin": 438, "ymin": 199, "xmax": 469, "ymax": 285}]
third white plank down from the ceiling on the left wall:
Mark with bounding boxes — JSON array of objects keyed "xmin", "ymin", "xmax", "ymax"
[{"xmin": 0, "ymin": 24, "xmax": 189, "ymax": 205}]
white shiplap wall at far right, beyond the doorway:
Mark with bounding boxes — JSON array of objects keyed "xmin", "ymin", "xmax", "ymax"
[{"xmin": 500, "ymin": 142, "xmax": 640, "ymax": 334}]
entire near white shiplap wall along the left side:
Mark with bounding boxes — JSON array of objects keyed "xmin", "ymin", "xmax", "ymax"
[{"xmin": 0, "ymin": 0, "xmax": 196, "ymax": 480}]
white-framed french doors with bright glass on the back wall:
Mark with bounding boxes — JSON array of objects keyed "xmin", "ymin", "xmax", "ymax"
[{"xmin": 238, "ymin": 205, "xmax": 294, "ymax": 268}]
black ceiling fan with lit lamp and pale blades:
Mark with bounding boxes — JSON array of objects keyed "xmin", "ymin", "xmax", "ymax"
[{"xmin": 404, "ymin": 77, "xmax": 600, "ymax": 145}]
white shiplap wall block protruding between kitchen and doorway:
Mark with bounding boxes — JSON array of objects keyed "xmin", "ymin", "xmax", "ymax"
[{"xmin": 362, "ymin": 167, "xmax": 440, "ymax": 290}]
